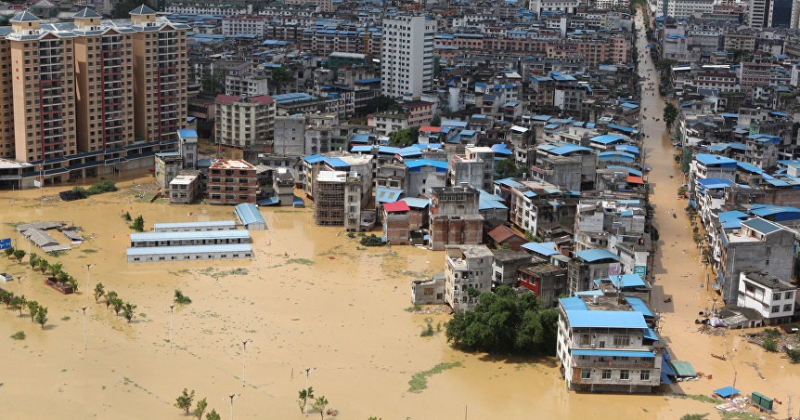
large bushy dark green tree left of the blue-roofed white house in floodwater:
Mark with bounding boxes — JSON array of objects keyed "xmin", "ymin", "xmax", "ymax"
[{"xmin": 445, "ymin": 286, "xmax": 558, "ymax": 354}]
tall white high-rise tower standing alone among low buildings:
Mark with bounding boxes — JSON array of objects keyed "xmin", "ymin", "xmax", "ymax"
[{"xmin": 381, "ymin": 16, "xmax": 436, "ymax": 99}]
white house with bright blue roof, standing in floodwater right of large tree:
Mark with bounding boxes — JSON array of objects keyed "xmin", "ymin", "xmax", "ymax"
[{"xmin": 556, "ymin": 295, "xmax": 664, "ymax": 393}]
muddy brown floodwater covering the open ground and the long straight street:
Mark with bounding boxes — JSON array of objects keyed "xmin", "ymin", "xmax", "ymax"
[{"xmin": 0, "ymin": 9, "xmax": 800, "ymax": 420}]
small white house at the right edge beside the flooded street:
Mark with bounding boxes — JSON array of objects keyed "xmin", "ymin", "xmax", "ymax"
[{"xmin": 736, "ymin": 268, "xmax": 797, "ymax": 325}]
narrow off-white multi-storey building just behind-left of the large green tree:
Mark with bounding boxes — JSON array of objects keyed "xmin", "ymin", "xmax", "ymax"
[{"xmin": 444, "ymin": 245, "xmax": 493, "ymax": 312}]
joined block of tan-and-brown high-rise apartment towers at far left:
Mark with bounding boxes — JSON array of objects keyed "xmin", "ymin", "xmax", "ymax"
[{"xmin": 0, "ymin": 6, "xmax": 189, "ymax": 188}]
